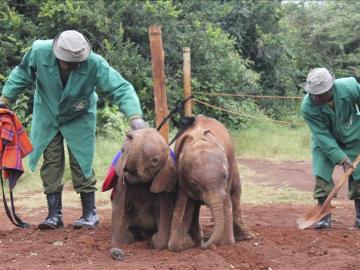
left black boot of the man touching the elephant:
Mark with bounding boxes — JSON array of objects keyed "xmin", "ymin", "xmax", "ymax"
[{"xmin": 38, "ymin": 191, "xmax": 64, "ymax": 230}]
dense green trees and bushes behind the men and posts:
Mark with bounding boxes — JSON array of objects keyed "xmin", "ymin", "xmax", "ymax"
[{"xmin": 0, "ymin": 0, "xmax": 360, "ymax": 135}]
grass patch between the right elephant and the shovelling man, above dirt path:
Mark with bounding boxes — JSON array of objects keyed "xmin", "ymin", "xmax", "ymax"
[{"xmin": 232, "ymin": 122, "xmax": 311, "ymax": 160}]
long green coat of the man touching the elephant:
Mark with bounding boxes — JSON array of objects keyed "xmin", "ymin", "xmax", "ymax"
[{"xmin": 2, "ymin": 40, "xmax": 142, "ymax": 177}]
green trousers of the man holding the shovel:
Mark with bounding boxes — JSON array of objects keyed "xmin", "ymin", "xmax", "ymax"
[{"xmin": 313, "ymin": 176, "xmax": 360, "ymax": 200}]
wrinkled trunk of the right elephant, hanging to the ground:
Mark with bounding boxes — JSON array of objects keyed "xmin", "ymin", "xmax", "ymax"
[{"xmin": 201, "ymin": 194, "xmax": 224, "ymax": 249}]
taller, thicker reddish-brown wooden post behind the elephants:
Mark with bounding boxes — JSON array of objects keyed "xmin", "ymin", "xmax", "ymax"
[{"xmin": 149, "ymin": 25, "xmax": 169, "ymax": 142}]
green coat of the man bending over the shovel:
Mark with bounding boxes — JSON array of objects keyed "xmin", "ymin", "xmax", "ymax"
[{"xmin": 301, "ymin": 78, "xmax": 360, "ymax": 181}]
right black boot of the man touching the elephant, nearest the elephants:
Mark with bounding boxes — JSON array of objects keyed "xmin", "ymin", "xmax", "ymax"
[{"xmin": 73, "ymin": 191, "xmax": 99, "ymax": 229}]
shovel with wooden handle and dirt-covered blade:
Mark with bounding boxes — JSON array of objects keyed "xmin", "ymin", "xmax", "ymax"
[{"xmin": 296, "ymin": 154, "xmax": 360, "ymax": 229}]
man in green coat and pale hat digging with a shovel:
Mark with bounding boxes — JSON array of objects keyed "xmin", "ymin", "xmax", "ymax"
[{"xmin": 301, "ymin": 68, "xmax": 360, "ymax": 229}]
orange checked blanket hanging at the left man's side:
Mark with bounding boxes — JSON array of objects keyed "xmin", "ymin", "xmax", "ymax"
[{"xmin": 0, "ymin": 108, "xmax": 32, "ymax": 190}]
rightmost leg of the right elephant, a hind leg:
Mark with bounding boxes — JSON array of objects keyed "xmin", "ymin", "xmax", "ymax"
[{"xmin": 230, "ymin": 174, "xmax": 254, "ymax": 241}]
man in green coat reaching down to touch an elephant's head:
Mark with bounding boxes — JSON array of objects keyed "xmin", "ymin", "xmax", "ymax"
[{"xmin": 0, "ymin": 30, "xmax": 146, "ymax": 229}]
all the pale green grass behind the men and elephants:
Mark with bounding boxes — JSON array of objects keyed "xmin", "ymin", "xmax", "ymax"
[{"xmin": 7, "ymin": 123, "xmax": 311, "ymax": 209}]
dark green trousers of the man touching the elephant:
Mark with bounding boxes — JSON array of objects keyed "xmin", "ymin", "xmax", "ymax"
[{"xmin": 40, "ymin": 132, "xmax": 96, "ymax": 194}]
